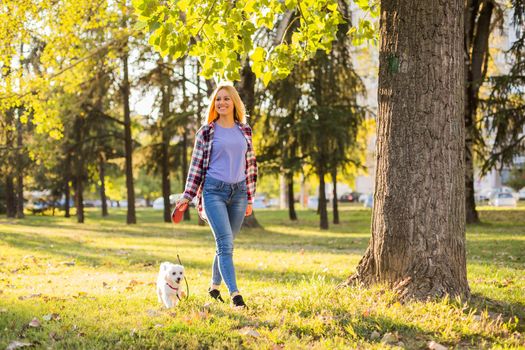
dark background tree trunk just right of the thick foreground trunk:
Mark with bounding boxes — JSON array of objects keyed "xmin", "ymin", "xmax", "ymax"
[{"xmin": 464, "ymin": 0, "xmax": 494, "ymax": 224}]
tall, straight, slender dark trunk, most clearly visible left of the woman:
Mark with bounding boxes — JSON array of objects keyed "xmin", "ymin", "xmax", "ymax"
[{"xmin": 121, "ymin": 53, "xmax": 137, "ymax": 224}]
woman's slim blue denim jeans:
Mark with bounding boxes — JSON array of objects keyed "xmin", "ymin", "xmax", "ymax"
[{"xmin": 202, "ymin": 176, "xmax": 248, "ymax": 294}]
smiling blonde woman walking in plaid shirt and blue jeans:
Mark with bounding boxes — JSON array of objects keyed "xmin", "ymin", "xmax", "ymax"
[{"xmin": 176, "ymin": 83, "xmax": 257, "ymax": 307}]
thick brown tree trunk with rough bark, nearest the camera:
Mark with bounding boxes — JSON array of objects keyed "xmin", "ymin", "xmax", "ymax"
[{"xmin": 346, "ymin": 0, "xmax": 469, "ymax": 299}]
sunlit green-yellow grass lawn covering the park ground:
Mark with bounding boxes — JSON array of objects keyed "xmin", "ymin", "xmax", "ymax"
[{"xmin": 0, "ymin": 206, "xmax": 525, "ymax": 349}]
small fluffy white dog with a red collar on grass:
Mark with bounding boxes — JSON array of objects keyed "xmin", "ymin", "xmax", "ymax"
[{"xmin": 157, "ymin": 262, "xmax": 186, "ymax": 309}]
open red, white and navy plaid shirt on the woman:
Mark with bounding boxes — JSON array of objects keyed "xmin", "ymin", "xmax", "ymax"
[{"xmin": 183, "ymin": 123, "xmax": 257, "ymax": 220}]
